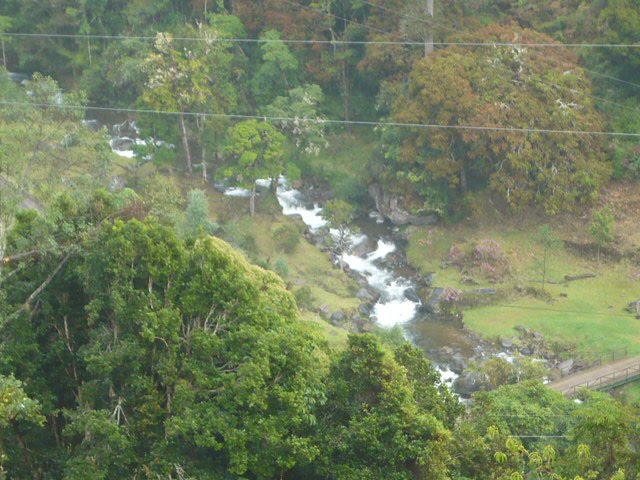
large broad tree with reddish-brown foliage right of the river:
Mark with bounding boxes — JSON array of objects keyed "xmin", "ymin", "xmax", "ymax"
[{"xmin": 389, "ymin": 26, "xmax": 611, "ymax": 214}]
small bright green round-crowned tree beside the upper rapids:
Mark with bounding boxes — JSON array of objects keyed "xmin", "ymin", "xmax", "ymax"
[{"xmin": 224, "ymin": 120, "xmax": 285, "ymax": 216}]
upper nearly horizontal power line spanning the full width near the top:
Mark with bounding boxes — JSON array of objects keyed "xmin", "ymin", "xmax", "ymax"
[{"xmin": 0, "ymin": 31, "xmax": 640, "ymax": 49}]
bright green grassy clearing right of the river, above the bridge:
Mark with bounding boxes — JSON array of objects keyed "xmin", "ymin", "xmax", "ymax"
[{"xmin": 408, "ymin": 216, "xmax": 640, "ymax": 353}]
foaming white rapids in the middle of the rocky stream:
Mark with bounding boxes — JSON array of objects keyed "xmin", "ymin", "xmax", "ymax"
[{"xmin": 277, "ymin": 179, "xmax": 420, "ymax": 328}]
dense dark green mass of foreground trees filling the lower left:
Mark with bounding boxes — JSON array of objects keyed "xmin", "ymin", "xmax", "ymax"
[{"xmin": 0, "ymin": 195, "xmax": 459, "ymax": 479}]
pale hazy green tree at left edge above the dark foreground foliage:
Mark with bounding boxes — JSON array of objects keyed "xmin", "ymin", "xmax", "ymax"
[{"xmin": 0, "ymin": 71, "xmax": 110, "ymax": 283}]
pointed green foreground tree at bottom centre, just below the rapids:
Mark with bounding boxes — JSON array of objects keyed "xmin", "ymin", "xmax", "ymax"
[{"xmin": 308, "ymin": 335, "xmax": 451, "ymax": 479}]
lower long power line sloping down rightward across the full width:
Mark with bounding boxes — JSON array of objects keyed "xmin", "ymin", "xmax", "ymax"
[{"xmin": 0, "ymin": 101, "xmax": 640, "ymax": 138}]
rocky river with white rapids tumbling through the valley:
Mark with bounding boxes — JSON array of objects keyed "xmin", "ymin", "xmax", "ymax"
[{"xmin": 102, "ymin": 121, "xmax": 512, "ymax": 385}]
